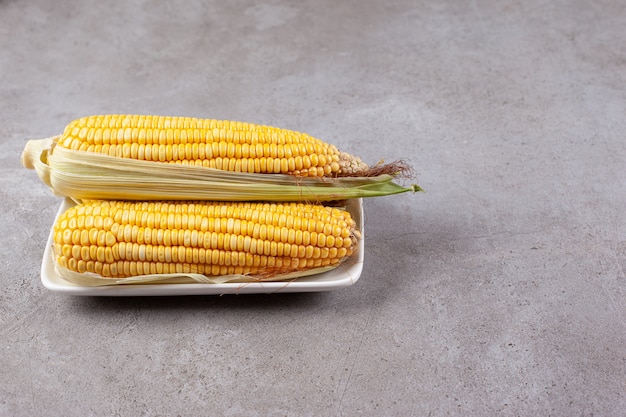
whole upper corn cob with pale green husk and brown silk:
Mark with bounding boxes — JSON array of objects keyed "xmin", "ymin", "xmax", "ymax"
[{"xmin": 22, "ymin": 115, "xmax": 421, "ymax": 201}]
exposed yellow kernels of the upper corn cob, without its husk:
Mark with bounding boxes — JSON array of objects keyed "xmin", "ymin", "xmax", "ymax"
[{"xmin": 57, "ymin": 115, "xmax": 368, "ymax": 177}]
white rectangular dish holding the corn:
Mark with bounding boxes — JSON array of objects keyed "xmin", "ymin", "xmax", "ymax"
[{"xmin": 41, "ymin": 199, "xmax": 365, "ymax": 297}]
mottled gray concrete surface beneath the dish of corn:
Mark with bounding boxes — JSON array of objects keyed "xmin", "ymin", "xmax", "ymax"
[{"xmin": 0, "ymin": 0, "xmax": 626, "ymax": 416}]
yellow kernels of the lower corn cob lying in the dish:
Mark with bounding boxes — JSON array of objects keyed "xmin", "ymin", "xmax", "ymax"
[{"xmin": 53, "ymin": 200, "xmax": 359, "ymax": 278}]
